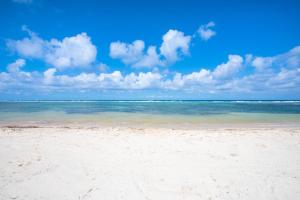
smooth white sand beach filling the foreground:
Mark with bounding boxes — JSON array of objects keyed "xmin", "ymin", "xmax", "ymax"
[{"xmin": 0, "ymin": 128, "xmax": 300, "ymax": 200}]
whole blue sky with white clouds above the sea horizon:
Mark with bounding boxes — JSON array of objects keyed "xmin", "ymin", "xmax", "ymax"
[{"xmin": 0, "ymin": 0, "xmax": 300, "ymax": 100}]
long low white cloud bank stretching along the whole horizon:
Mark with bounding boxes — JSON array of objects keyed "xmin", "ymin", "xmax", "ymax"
[{"xmin": 0, "ymin": 47, "xmax": 300, "ymax": 97}]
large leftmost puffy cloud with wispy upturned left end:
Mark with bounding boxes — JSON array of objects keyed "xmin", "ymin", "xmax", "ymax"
[{"xmin": 6, "ymin": 27, "xmax": 97, "ymax": 69}]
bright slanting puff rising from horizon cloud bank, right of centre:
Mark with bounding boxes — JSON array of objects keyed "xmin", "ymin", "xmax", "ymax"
[{"xmin": 213, "ymin": 55, "xmax": 243, "ymax": 78}]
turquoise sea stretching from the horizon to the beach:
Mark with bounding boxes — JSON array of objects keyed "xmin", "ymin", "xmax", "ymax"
[{"xmin": 0, "ymin": 101, "xmax": 300, "ymax": 124}]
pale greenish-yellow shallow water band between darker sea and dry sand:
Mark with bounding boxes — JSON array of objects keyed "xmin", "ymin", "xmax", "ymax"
[{"xmin": 0, "ymin": 112, "xmax": 300, "ymax": 129}]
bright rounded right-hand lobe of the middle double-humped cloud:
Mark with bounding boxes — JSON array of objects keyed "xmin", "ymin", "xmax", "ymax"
[{"xmin": 160, "ymin": 29, "xmax": 191, "ymax": 63}]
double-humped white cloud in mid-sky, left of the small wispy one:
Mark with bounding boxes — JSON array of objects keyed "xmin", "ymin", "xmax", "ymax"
[{"xmin": 110, "ymin": 30, "xmax": 191, "ymax": 68}]
